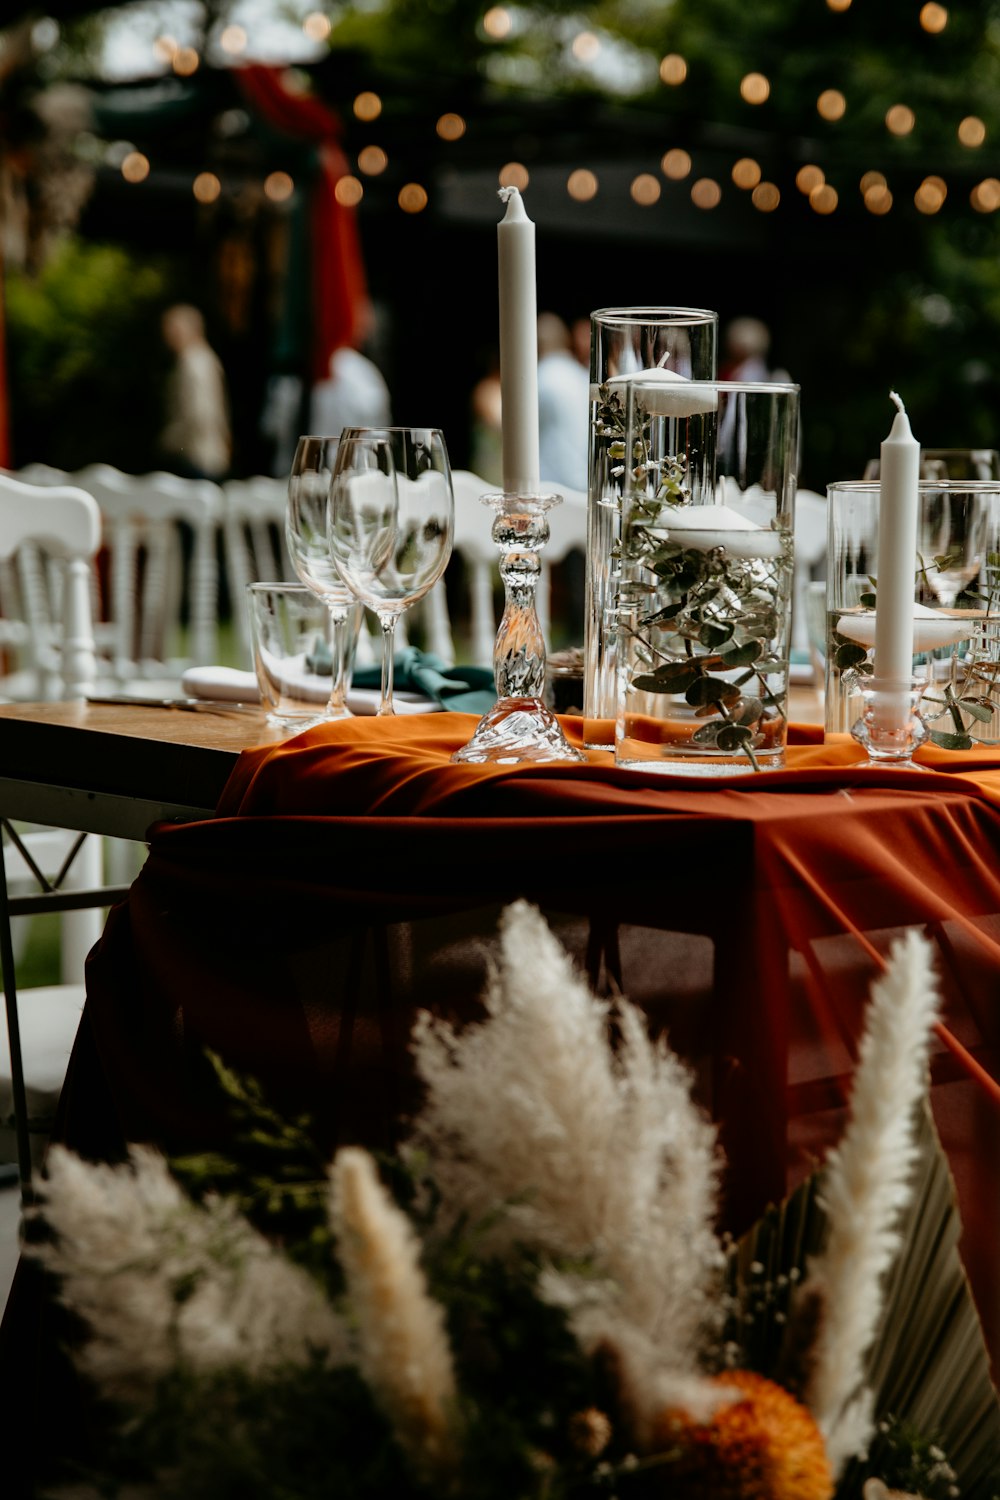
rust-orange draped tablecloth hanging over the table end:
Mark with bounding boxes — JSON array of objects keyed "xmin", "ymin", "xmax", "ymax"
[{"xmin": 4, "ymin": 714, "xmax": 1000, "ymax": 1488}]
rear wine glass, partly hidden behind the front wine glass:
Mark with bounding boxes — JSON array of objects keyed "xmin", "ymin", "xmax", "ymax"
[{"xmin": 285, "ymin": 437, "xmax": 361, "ymax": 720}]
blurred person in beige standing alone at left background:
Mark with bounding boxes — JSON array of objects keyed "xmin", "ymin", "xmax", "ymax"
[{"xmin": 159, "ymin": 303, "xmax": 232, "ymax": 480}]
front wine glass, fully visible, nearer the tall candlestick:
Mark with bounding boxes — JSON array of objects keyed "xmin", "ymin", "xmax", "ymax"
[{"xmin": 328, "ymin": 428, "xmax": 454, "ymax": 716}]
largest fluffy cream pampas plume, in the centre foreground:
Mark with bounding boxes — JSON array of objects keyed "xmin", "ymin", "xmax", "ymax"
[{"xmin": 411, "ymin": 902, "xmax": 723, "ymax": 1434}]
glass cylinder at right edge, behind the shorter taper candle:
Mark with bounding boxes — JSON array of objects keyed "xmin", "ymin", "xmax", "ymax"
[{"xmin": 823, "ymin": 480, "xmax": 1000, "ymax": 750}]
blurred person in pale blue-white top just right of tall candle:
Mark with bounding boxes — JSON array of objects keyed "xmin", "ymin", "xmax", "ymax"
[{"xmin": 538, "ymin": 312, "xmax": 591, "ymax": 491}]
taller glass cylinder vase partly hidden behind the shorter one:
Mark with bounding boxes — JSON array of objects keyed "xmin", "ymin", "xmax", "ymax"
[{"xmin": 583, "ymin": 308, "xmax": 718, "ymax": 750}]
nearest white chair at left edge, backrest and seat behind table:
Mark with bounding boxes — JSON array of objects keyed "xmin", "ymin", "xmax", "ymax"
[{"xmin": 0, "ymin": 474, "xmax": 117, "ymax": 1191}]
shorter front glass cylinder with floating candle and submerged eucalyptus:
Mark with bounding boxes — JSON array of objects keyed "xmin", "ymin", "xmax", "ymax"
[{"xmin": 615, "ymin": 380, "xmax": 799, "ymax": 776}]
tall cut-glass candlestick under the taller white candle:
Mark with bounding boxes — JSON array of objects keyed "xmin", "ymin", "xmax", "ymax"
[{"xmin": 451, "ymin": 494, "xmax": 586, "ymax": 765}]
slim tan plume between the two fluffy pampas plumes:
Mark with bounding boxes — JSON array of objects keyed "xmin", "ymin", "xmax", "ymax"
[{"xmin": 330, "ymin": 1146, "xmax": 454, "ymax": 1472}]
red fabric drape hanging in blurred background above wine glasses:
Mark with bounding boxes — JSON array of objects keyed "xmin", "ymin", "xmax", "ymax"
[{"xmin": 234, "ymin": 63, "xmax": 367, "ymax": 381}]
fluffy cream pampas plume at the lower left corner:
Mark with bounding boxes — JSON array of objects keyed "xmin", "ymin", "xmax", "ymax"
[{"xmin": 27, "ymin": 1146, "xmax": 349, "ymax": 1403}]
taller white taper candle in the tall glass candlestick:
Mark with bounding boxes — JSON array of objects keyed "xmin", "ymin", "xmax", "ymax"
[{"xmin": 496, "ymin": 188, "xmax": 541, "ymax": 495}]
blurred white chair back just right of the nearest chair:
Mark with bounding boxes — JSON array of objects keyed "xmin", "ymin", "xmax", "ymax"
[{"xmin": 73, "ymin": 464, "xmax": 223, "ymax": 695}]
